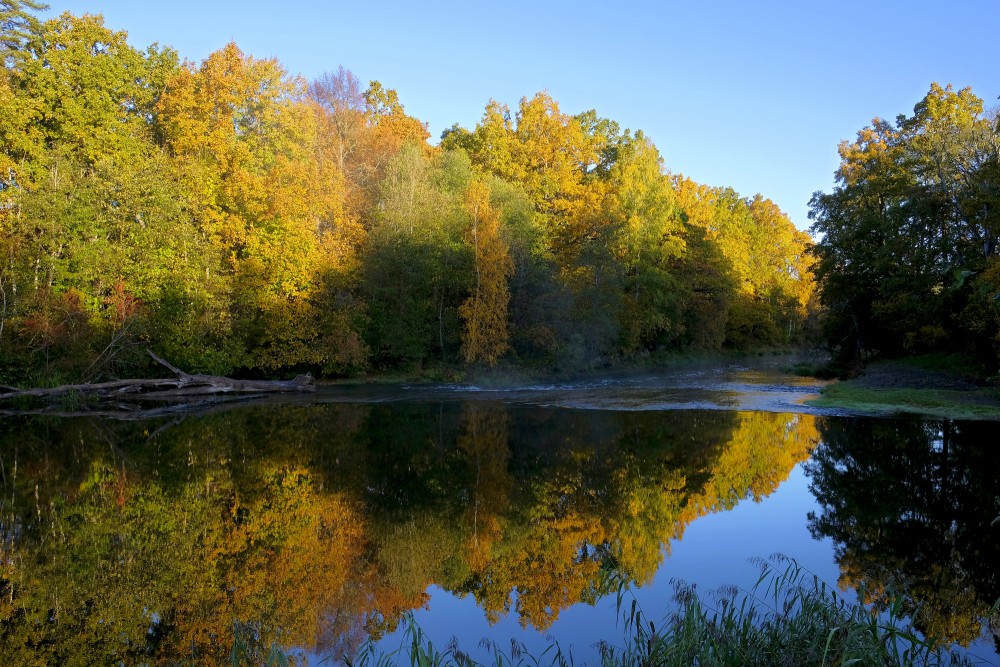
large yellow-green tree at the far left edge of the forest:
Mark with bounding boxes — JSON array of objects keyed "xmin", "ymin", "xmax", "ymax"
[{"xmin": 0, "ymin": 9, "xmax": 185, "ymax": 377}]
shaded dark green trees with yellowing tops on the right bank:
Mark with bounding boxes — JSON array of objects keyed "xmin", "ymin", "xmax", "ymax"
[{"xmin": 810, "ymin": 84, "xmax": 1000, "ymax": 368}]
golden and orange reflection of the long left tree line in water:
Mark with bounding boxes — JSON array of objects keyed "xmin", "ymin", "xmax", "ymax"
[{"xmin": 0, "ymin": 402, "xmax": 818, "ymax": 665}]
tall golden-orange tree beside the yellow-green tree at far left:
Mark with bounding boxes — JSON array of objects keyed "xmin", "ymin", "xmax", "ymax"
[{"xmin": 157, "ymin": 44, "xmax": 361, "ymax": 369}]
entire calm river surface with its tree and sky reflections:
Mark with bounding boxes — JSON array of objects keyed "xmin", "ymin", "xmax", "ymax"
[{"xmin": 0, "ymin": 369, "xmax": 1000, "ymax": 665}]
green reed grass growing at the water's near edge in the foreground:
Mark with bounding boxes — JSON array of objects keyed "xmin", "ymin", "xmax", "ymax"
[{"xmin": 346, "ymin": 556, "xmax": 973, "ymax": 667}]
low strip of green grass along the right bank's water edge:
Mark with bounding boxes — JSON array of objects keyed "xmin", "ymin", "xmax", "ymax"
[{"xmin": 806, "ymin": 380, "xmax": 1000, "ymax": 419}]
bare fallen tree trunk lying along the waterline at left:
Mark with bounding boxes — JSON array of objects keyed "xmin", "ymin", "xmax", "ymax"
[{"xmin": 0, "ymin": 350, "xmax": 316, "ymax": 410}]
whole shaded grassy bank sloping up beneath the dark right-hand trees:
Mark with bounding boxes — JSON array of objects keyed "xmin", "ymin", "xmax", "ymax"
[{"xmin": 805, "ymin": 355, "xmax": 1000, "ymax": 420}]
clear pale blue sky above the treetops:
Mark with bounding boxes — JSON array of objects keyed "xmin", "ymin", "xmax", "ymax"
[{"xmin": 43, "ymin": 0, "xmax": 1000, "ymax": 234}]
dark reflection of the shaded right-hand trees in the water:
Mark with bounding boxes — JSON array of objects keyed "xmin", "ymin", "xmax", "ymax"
[{"xmin": 807, "ymin": 419, "xmax": 1000, "ymax": 652}]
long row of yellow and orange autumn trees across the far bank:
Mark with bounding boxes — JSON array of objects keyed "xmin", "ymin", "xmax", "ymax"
[{"xmin": 0, "ymin": 0, "xmax": 815, "ymax": 383}]
